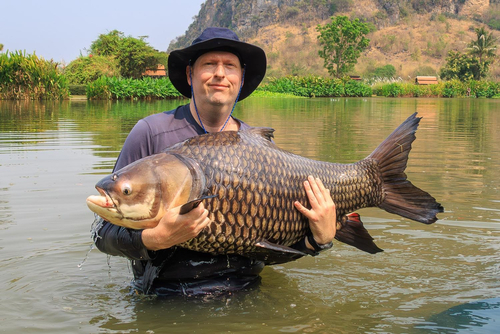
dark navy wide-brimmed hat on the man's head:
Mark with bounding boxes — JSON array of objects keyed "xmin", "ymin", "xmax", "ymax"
[{"xmin": 168, "ymin": 28, "xmax": 267, "ymax": 101}]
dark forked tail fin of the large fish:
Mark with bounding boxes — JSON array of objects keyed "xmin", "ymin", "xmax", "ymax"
[{"xmin": 368, "ymin": 113, "xmax": 444, "ymax": 224}]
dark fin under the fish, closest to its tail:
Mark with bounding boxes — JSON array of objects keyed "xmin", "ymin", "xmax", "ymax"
[{"xmin": 335, "ymin": 212, "xmax": 383, "ymax": 254}]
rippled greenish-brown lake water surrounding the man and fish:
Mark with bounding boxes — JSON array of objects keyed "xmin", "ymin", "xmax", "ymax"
[{"xmin": 0, "ymin": 98, "xmax": 500, "ymax": 333}]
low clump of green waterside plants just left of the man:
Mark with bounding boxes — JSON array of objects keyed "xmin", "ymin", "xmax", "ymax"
[{"xmin": 87, "ymin": 77, "xmax": 182, "ymax": 100}]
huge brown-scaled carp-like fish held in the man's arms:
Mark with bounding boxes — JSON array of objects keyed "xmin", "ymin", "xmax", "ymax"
[{"xmin": 87, "ymin": 113, "xmax": 443, "ymax": 263}]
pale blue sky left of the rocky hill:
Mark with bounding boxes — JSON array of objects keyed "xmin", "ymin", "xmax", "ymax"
[{"xmin": 0, "ymin": 0, "xmax": 205, "ymax": 64}]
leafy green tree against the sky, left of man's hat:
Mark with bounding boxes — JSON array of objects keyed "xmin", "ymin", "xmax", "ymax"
[{"xmin": 90, "ymin": 30, "xmax": 164, "ymax": 78}]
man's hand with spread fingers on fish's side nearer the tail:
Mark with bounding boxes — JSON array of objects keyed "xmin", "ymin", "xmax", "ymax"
[{"xmin": 294, "ymin": 176, "xmax": 337, "ymax": 249}]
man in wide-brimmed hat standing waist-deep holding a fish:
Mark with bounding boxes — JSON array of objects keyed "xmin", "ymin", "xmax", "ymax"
[{"xmin": 94, "ymin": 28, "xmax": 336, "ymax": 295}]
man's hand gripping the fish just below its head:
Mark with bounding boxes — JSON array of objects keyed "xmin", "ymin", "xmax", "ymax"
[{"xmin": 142, "ymin": 203, "xmax": 210, "ymax": 250}]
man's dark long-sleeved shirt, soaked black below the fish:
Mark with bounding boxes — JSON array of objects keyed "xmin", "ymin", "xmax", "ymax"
[{"xmin": 94, "ymin": 105, "xmax": 264, "ymax": 295}]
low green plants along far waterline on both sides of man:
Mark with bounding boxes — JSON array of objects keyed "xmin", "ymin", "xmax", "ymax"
[{"xmin": 72, "ymin": 76, "xmax": 500, "ymax": 100}]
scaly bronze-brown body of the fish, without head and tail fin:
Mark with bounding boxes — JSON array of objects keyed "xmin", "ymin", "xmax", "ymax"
[{"xmin": 166, "ymin": 128, "xmax": 382, "ymax": 254}]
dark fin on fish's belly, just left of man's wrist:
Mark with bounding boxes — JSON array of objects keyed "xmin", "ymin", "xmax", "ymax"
[{"xmin": 246, "ymin": 239, "xmax": 307, "ymax": 265}]
